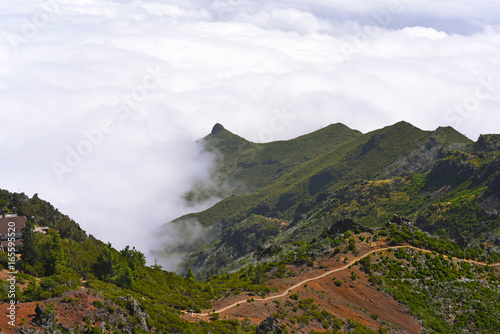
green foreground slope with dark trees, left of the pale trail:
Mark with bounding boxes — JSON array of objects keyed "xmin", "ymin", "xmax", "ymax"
[{"xmin": 0, "ymin": 190, "xmax": 271, "ymax": 334}]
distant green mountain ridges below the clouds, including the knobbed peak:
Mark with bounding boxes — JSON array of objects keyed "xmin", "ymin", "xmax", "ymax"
[{"xmin": 186, "ymin": 122, "xmax": 471, "ymax": 225}]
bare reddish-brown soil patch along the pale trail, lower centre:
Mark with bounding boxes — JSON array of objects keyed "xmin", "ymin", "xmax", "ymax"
[{"xmin": 183, "ymin": 239, "xmax": 421, "ymax": 333}]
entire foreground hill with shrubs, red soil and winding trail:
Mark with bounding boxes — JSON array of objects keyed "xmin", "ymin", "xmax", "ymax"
[{"xmin": 0, "ymin": 192, "xmax": 500, "ymax": 334}]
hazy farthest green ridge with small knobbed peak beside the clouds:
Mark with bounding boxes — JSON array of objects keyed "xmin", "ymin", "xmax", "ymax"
[{"xmin": 186, "ymin": 124, "xmax": 361, "ymax": 203}]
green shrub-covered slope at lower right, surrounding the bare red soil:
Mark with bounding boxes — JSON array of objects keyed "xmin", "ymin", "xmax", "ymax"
[{"xmin": 246, "ymin": 216, "xmax": 500, "ymax": 333}]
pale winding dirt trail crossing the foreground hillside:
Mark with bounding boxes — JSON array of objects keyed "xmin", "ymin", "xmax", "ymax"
[{"xmin": 188, "ymin": 245, "xmax": 500, "ymax": 317}]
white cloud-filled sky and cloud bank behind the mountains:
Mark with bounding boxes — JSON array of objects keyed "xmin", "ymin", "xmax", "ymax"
[{"xmin": 0, "ymin": 0, "xmax": 500, "ymax": 264}]
